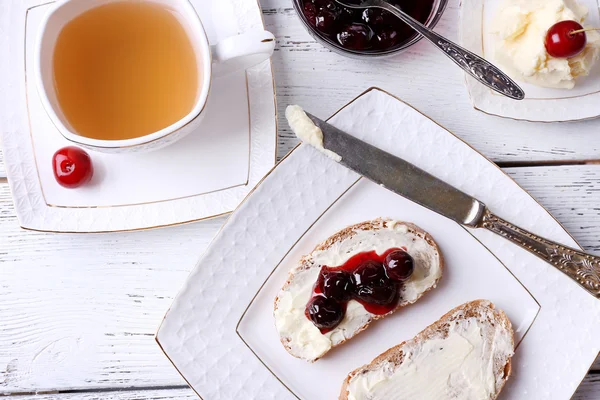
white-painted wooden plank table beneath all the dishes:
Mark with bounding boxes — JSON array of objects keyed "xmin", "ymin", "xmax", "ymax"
[{"xmin": 0, "ymin": 0, "xmax": 600, "ymax": 400}]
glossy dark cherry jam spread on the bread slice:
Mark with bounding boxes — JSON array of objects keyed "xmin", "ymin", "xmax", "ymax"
[{"xmin": 306, "ymin": 248, "xmax": 414, "ymax": 334}]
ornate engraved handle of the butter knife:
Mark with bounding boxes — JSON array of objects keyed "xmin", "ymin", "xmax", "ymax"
[{"xmin": 480, "ymin": 211, "xmax": 600, "ymax": 298}]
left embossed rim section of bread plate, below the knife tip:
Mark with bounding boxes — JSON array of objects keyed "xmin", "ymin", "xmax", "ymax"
[{"xmin": 158, "ymin": 146, "xmax": 356, "ymax": 399}]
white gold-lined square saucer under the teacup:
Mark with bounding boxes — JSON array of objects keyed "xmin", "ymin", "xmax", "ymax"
[{"xmin": 0, "ymin": 0, "xmax": 277, "ymax": 232}]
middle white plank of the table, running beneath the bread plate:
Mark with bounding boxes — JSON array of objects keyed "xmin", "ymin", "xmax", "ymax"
[{"xmin": 0, "ymin": 165, "xmax": 600, "ymax": 395}]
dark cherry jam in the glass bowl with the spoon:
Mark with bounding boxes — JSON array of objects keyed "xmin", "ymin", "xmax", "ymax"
[{"xmin": 301, "ymin": 0, "xmax": 434, "ymax": 51}]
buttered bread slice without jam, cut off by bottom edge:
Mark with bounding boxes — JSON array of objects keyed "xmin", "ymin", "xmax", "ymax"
[{"xmin": 339, "ymin": 300, "xmax": 514, "ymax": 400}]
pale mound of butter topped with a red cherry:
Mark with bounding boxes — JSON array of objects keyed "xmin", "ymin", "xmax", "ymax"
[{"xmin": 491, "ymin": 0, "xmax": 600, "ymax": 89}]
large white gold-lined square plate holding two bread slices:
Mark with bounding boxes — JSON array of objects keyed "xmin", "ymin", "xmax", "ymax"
[{"xmin": 157, "ymin": 89, "xmax": 600, "ymax": 400}]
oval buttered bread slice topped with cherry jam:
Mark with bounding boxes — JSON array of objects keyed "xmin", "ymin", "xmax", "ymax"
[{"xmin": 274, "ymin": 219, "xmax": 444, "ymax": 362}]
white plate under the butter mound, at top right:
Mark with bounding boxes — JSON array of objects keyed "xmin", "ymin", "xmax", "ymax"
[{"xmin": 460, "ymin": 0, "xmax": 600, "ymax": 122}]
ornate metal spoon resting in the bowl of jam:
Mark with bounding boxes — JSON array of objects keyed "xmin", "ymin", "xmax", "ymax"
[{"xmin": 335, "ymin": 0, "xmax": 525, "ymax": 100}]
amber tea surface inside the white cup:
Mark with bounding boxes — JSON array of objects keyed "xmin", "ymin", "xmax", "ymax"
[{"xmin": 54, "ymin": 1, "xmax": 200, "ymax": 140}]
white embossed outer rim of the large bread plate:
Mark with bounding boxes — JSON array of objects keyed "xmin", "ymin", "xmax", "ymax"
[{"xmin": 157, "ymin": 90, "xmax": 600, "ymax": 400}]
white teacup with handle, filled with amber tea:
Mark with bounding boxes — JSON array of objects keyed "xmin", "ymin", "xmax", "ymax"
[{"xmin": 36, "ymin": 0, "xmax": 275, "ymax": 152}]
